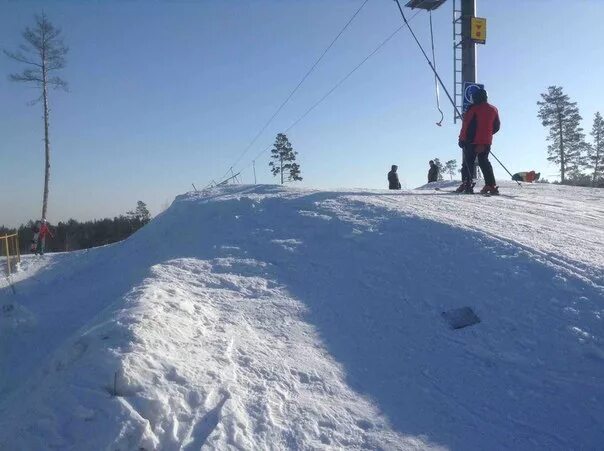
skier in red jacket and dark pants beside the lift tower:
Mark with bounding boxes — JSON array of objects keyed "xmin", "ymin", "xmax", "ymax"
[{"xmin": 457, "ymin": 89, "xmax": 501, "ymax": 194}]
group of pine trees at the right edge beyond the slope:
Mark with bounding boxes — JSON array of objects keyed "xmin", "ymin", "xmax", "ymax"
[{"xmin": 537, "ymin": 86, "xmax": 604, "ymax": 188}]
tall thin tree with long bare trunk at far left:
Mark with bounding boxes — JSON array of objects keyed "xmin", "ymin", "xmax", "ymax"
[{"xmin": 4, "ymin": 13, "xmax": 68, "ymax": 223}]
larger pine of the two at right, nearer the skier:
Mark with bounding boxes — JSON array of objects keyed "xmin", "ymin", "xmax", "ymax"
[{"xmin": 537, "ymin": 86, "xmax": 586, "ymax": 183}]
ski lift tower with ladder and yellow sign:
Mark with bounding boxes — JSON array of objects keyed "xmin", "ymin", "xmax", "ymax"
[{"xmin": 405, "ymin": 0, "xmax": 486, "ymax": 122}]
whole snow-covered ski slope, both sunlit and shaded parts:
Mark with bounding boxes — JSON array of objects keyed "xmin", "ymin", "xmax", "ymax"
[{"xmin": 0, "ymin": 183, "xmax": 604, "ymax": 450}]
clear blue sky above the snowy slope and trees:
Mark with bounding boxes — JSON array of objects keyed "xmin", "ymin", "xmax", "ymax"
[{"xmin": 0, "ymin": 0, "xmax": 604, "ymax": 225}]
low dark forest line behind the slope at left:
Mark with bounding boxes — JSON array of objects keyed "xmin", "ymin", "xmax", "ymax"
[{"xmin": 0, "ymin": 201, "xmax": 151, "ymax": 254}]
